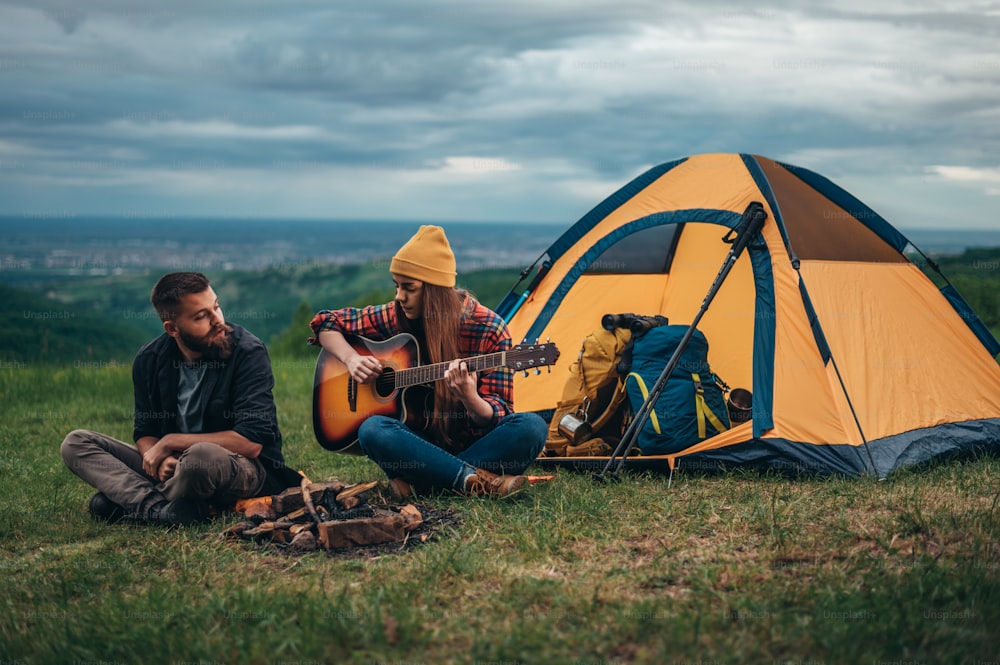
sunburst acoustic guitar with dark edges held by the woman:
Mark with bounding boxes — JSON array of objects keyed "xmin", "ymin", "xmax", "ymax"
[{"xmin": 313, "ymin": 333, "xmax": 559, "ymax": 455}]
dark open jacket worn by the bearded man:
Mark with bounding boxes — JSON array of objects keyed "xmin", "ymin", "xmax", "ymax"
[{"xmin": 132, "ymin": 326, "xmax": 301, "ymax": 494}]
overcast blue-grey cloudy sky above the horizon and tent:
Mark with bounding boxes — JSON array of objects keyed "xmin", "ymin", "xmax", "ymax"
[{"xmin": 0, "ymin": 0, "xmax": 1000, "ymax": 229}]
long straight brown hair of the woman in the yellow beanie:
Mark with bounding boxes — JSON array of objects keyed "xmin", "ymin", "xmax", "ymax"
[{"xmin": 402, "ymin": 282, "xmax": 471, "ymax": 447}]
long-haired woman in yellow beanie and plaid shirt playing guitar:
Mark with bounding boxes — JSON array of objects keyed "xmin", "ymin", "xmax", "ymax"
[{"xmin": 311, "ymin": 226, "xmax": 550, "ymax": 497}]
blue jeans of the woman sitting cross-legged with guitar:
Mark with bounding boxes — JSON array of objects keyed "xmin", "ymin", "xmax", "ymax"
[{"xmin": 358, "ymin": 413, "xmax": 548, "ymax": 491}]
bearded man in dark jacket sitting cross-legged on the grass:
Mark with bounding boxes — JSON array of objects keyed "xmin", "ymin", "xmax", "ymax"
[{"xmin": 60, "ymin": 272, "xmax": 300, "ymax": 525}]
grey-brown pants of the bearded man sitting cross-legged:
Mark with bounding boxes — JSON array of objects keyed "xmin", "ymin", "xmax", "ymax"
[{"xmin": 60, "ymin": 429, "xmax": 266, "ymax": 519}]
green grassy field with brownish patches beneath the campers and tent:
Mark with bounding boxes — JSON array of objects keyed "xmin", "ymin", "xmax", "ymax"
[{"xmin": 0, "ymin": 359, "xmax": 1000, "ymax": 665}]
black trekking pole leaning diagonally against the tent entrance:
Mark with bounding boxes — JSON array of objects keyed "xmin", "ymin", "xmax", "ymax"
[{"xmin": 594, "ymin": 201, "xmax": 767, "ymax": 483}]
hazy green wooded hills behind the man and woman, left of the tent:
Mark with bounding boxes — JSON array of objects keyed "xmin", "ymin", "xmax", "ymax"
[{"xmin": 0, "ymin": 262, "xmax": 517, "ymax": 363}]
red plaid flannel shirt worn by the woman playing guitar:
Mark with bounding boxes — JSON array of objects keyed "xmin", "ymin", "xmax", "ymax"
[{"xmin": 310, "ymin": 296, "xmax": 514, "ymax": 448}]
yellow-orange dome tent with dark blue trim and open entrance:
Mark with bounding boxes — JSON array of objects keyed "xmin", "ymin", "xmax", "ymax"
[{"xmin": 497, "ymin": 154, "xmax": 1000, "ymax": 477}]
